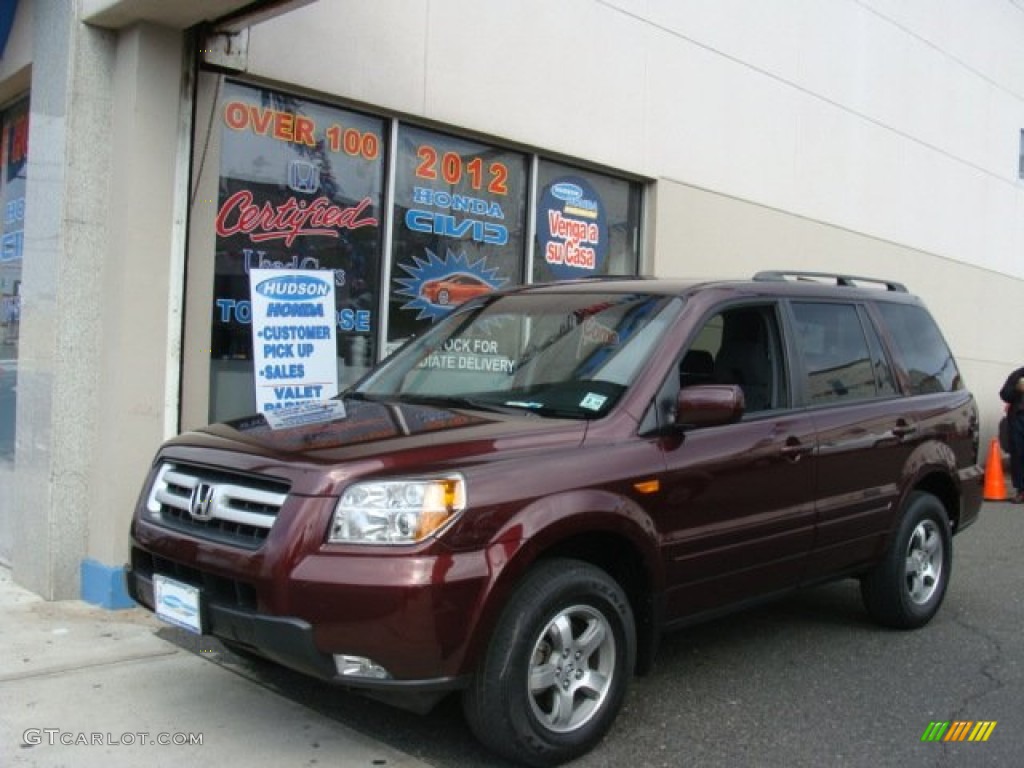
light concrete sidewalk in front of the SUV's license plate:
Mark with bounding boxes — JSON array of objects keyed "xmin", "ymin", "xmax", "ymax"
[{"xmin": 0, "ymin": 567, "xmax": 426, "ymax": 768}]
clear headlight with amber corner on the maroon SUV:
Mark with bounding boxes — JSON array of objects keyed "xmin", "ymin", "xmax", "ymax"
[{"xmin": 328, "ymin": 474, "xmax": 466, "ymax": 544}]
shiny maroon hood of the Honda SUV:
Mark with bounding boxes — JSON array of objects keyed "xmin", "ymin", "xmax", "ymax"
[{"xmin": 164, "ymin": 398, "xmax": 587, "ymax": 470}]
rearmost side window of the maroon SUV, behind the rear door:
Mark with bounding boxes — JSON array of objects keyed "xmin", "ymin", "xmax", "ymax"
[{"xmin": 879, "ymin": 304, "xmax": 964, "ymax": 394}]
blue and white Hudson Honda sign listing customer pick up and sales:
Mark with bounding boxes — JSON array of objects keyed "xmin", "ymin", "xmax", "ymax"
[{"xmin": 249, "ymin": 269, "xmax": 338, "ymax": 414}]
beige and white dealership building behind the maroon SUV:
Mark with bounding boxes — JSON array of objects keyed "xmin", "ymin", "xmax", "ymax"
[{"xmin": 0, "ymin": 0, "xmax": 1024, "ymax": 607}]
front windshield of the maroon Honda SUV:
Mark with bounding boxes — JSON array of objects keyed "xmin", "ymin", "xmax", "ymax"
[{"xmin": 348, "ymin": 293, "xmax": 682, "ymax": 419}]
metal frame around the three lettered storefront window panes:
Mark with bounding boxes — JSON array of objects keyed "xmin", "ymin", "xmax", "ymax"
[{"xmin": 189, "ymin": 68, "xmax": 650, "ymax": 427}]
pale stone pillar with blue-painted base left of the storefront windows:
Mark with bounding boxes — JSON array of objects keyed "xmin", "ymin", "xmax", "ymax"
[{"xmin": 5, "ymin": 0, "xmax": 186, "ymax": 602}]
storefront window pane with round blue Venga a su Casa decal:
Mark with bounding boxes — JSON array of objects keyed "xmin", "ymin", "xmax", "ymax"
[{"xmin": 532, "ymin": 160, "xmax": 640, "ymax": 283}]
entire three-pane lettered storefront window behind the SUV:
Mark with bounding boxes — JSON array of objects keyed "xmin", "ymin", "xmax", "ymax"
[{"xmin": 192, "ymin": 78, "xmax": 642, "ymax": 428}]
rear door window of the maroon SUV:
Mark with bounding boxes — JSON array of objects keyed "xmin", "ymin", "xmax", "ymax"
[{"xmin": 793, "ymin": 302, "xmax": 892, "ymax": 404}]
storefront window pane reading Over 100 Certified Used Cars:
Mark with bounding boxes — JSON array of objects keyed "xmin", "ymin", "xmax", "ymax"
[{"xmin": 210, "ymin": 82, "xmax": 387, "ymax": 419}]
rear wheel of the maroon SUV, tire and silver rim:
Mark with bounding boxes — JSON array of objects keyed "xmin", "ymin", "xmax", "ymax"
[{"xmin": 860, "ymin": 492, "xmax": 953, "ymax": 630}]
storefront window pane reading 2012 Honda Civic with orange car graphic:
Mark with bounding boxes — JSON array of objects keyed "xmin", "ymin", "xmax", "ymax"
[{"xmin": 388, "ymin": 126, "xmax": 527, "ymax": 346}]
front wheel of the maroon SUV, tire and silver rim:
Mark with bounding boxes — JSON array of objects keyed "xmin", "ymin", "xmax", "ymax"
[{"xmin": 463, "ymin": 559, "xmax": 636, "ymax": 766}]
